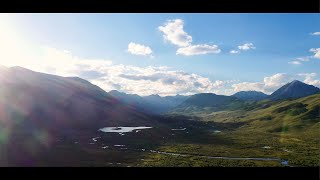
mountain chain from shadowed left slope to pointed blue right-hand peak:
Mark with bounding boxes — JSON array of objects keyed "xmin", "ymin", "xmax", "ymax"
[{"xmin": 0, "ymin": 67, "xmax": 320, "ymax": 124}]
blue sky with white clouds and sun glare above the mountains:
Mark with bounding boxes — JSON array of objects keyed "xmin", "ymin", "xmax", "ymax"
[{"xmin": 0, "ymin": 13, "xmax": 320, "ymax": 96}]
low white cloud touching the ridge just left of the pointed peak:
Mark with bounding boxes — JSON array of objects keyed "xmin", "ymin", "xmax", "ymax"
[{"xmin": 232, "ymin": 73, "xmax": 294, "ymax": 94}]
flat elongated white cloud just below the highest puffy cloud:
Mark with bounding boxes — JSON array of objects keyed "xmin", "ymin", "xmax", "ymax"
[{"xmin": 176, "ymin": 44, "xmax": 221, "ymax": 56}]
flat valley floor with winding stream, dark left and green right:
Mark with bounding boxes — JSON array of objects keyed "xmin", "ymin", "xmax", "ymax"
[{"xmin": 2, "ymin": 116, "xmax": 320, "ymax": 167}]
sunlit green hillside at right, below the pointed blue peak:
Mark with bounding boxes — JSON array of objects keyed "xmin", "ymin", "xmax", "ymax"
[{"xmin": 194, "ymin": 94, "xmax": 320, "ymax": 132}]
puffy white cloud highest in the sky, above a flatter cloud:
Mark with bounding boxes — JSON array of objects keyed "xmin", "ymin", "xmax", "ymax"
[{"xmin": 158, "ymin": 19, "xmax": 192, "ymax": 47}]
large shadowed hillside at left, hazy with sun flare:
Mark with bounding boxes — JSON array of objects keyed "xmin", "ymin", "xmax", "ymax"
[{"xmin": 0, "ymin": 67, "xmax": 161, "ymax": 129}]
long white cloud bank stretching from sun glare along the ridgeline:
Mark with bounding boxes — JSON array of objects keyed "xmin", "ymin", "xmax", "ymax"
[{"xmin": 15, "ymin": 47, "xmax": 232, "ymax": 96}]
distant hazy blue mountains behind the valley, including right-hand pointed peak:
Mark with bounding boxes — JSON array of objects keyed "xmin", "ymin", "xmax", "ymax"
[{"xmin": 109, "ymin": 80, "xmax": 320, "ymax": 114}]
